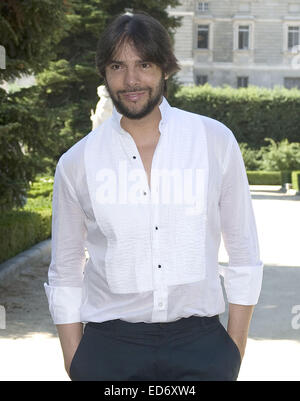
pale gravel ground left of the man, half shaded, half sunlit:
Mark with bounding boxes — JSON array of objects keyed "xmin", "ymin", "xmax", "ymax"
[{"xmin": 0, "ymin": 265, "xmax": 69, "ymax": 381}]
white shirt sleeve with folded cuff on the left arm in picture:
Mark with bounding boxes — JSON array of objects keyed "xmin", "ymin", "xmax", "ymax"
[{"xmin": 44, "ymin": 159, "xmax": 86, "ymax": 324}]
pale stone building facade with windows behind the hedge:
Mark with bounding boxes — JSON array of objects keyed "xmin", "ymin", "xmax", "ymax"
[{"xmin": 168, "ymin": 0, "xmax": 300, "ymax": 89}]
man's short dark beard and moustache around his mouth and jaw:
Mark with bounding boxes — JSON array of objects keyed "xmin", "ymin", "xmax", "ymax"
[{"xmin": 105, "ymin": 74, "xmax": 165, "ymax": 120}]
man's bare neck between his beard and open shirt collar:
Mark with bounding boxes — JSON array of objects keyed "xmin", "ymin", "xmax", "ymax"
[{"xmin": 120, "ymin": 106, "xmax": 161, "ymax": 146}]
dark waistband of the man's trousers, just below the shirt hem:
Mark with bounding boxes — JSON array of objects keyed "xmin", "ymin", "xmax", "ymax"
[{"xmin": 87, "ymin": 315, "xmax": 220, "ymax": 333}]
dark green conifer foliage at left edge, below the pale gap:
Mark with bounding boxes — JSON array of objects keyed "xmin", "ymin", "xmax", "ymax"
[{"xmin": 0, "ymin": 87, "xmax": 57, "ymax": 212}]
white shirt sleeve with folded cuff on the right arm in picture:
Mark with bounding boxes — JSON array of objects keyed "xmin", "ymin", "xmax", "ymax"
[{"xmin": 219, "ymin": 134, "xmax": 263, "ymax": 305}]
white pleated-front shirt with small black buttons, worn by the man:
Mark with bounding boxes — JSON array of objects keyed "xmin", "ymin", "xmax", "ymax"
[{"xmin": 45, "ymin": 98, "xmax": 263, "ymax": 324}]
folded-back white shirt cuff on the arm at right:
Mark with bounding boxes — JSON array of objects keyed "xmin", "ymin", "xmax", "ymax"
[{"xmin": 219, "ymin": 261, "xmax": 264, "ymax": 305}]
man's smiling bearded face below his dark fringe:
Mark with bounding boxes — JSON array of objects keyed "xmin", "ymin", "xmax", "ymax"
[{"xmin": 105, "ymin": 43, "xmax": 165, "ymax": 119}]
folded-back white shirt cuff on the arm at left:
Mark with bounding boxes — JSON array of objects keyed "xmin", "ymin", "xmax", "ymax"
[{"xmin": 44, "ymin": 283, "xmax": 82, "ymax": 324}]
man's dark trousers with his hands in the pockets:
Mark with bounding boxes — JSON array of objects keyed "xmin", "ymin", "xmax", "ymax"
[{"xmin": 70, "ymin": 316, "xmax": 241, "ymax": 381}]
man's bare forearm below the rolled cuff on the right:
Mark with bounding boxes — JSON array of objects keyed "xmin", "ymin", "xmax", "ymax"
[{"xmin": 227, "ymin": 304, "xmax": 254, "ymax": 359}]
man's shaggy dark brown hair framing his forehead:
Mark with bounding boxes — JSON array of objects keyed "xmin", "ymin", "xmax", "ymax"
[{"xmin": 96, "ymin": 12, "xmax": 180, "ymax": 78}]
